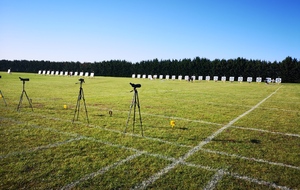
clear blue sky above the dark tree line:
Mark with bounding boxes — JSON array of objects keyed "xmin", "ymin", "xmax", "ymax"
[{"xmin": 0, "ymin": 0, "xmax": 300, "ymax": 62}]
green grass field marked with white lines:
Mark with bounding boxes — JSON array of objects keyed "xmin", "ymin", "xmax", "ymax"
[{"xmin": 0, "ymin": 72, "xmax": 300, "ymax": 189}]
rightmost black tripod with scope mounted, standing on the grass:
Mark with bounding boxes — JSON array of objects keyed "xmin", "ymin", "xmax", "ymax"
[{"xmin": 124, "ymin": 83, "xmax": 144, "ymax": 136}]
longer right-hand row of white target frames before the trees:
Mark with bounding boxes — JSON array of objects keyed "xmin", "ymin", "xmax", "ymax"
[{"xmin": 132, "ymin": 74, "xmax": 282, "ymax": 83}]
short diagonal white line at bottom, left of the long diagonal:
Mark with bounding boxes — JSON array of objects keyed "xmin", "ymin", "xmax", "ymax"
[{"xmin": 62, "ymin": 152, "xmax": 143, "ymax": 189}]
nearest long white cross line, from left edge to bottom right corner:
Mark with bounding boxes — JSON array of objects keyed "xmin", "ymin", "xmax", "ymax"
[{"xmin": 2, "ymin": 115, "xmax": 296, "ymax": 189}]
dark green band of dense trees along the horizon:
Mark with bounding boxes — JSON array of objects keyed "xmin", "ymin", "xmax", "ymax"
[{"xmin": 0, "ymin": 57, "xmax": 300, "ymax": 83}]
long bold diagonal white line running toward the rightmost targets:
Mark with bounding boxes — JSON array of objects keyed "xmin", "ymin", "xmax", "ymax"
[{"xmin": 134, "ymin": 87, "xmax": 281, "ymax": 189}]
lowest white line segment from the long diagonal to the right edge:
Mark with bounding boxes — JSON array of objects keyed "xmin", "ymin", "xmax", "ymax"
[{"xmin": 200, "ymin": 148, "xmax": 300, "ymax": 170}]
